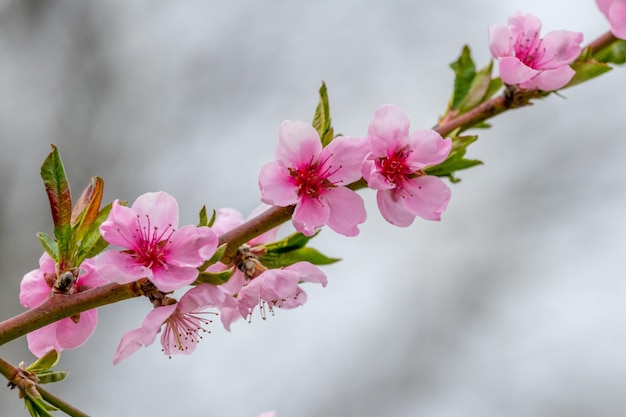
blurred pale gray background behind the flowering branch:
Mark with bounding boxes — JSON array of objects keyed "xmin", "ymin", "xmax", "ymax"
[{"xmin": 0, "ymin": 0, "xmax": 626, "ymax": 417}]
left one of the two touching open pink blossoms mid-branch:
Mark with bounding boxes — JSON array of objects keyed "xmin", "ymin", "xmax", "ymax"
[{"xmin": 259, "ymin": 120, "xmax": 366, "ymax": 236}]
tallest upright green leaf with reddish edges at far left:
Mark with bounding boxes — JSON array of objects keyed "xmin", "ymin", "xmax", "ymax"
[{"xmin": 40, "ymin": 145, "xmax": 72, "ymax": 269}]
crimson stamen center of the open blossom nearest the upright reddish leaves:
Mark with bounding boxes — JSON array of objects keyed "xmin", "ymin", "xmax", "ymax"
[{"xmin": 126, "ymin": 215, "xmax": 175, "ymax": 269}]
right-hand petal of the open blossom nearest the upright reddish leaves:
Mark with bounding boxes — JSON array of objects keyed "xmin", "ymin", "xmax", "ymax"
[{"xmin": 166, "ymin": 226, "xmax": 218, "ymax": 268}]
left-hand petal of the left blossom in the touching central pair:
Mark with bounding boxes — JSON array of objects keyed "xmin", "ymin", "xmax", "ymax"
[{"xmin": 259, "ymin": 161, "xmax": 298, "ymax": 207}]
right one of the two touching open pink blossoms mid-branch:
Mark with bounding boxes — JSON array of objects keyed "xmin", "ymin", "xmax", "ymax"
[{"xmin": 362, "ymin": 104, "xmax": 452, "ymax": 227}]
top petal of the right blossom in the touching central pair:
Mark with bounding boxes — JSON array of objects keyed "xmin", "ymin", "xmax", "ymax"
[{"xmin": 367, "ymin": 104, "xmax": 410, "ymax": 158}]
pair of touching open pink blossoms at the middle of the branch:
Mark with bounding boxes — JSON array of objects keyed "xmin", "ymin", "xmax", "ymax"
[{"xmin": 259, "ymin": 105, "xmax": 452, "ymax": 229}]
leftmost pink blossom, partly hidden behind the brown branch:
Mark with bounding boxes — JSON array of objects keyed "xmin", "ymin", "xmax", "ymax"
[{"xmin": 20, "ymin": 253, "xmax": 109, "ymax": 357}]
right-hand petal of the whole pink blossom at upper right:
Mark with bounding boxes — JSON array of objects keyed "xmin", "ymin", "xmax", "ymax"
[{"xmin": 534, "ymin": 30, "xmax": 583, "ymax": 69}]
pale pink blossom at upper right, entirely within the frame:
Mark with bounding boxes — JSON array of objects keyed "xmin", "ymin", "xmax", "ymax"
[{"xmin": 489, "ymin": 13, "xmax": 583, "ymax": 91}]
